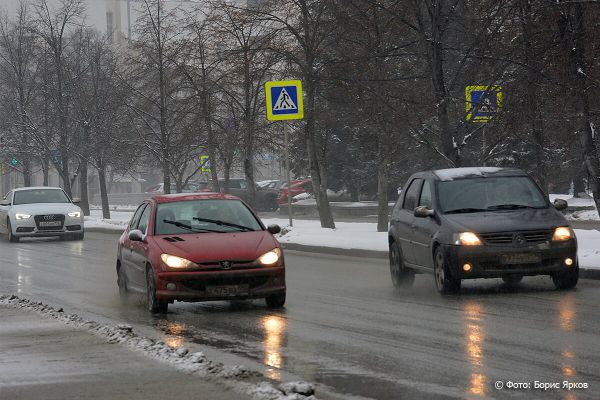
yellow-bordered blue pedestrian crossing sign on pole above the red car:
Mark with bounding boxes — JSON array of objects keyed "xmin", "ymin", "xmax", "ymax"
[{"xmin": 265, "ymin": 81, "xmax": 304, "ymax": 121}]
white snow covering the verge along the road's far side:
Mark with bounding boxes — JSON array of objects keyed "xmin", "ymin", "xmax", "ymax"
[{"xmin": 85, "ymin": 210, "xmax": 600, "ymax": 269}]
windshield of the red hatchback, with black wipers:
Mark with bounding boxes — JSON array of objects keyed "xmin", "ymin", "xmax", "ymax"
[{"xmin": 154, "ymin": 199, "xmax": 262, "ymax": 235}]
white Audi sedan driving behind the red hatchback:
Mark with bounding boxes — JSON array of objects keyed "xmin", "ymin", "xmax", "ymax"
[{"xmin": 0, "ymin": 186, "xmax": 84, "ymax": 242}]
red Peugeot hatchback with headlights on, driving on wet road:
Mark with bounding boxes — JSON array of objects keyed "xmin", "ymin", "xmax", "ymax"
[{"xmin": 117, "ymin": 193, "xmax": 286, "ymax": 313}]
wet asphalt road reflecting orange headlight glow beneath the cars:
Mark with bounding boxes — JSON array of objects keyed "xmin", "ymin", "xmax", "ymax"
[{"xmin": 0, "ymin": 233, "xmax": 600, "ymax": 399}]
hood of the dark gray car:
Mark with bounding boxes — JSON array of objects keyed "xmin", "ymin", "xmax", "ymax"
[{"xmin": 444, "ymin": 208, "xmax": 570, "ymax": 233}]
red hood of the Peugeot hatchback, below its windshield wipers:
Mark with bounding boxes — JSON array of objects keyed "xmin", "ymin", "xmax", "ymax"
[{"xmin": 154, "ymin": 231, "xmax": 279, "ymax": 264}]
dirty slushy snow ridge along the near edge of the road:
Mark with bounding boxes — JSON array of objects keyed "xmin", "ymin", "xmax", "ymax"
[{"xmin": 0, "ymin": 295, "xmax": 317, "ymax": 400}]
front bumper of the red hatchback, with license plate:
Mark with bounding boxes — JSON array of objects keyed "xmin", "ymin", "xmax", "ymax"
[{"xmin": 156, "ymin": 267, "xmax": 286, "ymax": 301}]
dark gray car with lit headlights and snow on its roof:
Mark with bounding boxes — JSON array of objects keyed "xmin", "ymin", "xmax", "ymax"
[{"xmin": 389, "ymin": 167, "xmax": 579, "ymax": 293}]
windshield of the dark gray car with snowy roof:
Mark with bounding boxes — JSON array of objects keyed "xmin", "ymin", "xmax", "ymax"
[{"xmin": 438, "ymin": 176, "xmax": 548, "ymax": 213}]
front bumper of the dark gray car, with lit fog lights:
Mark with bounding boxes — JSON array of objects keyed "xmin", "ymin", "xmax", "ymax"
[{"xmin": 444, "ymin": 240, "xmax": 577, "ymax": 279}]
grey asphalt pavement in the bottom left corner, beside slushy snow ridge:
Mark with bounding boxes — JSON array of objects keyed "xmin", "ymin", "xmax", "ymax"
[{"xmin": 0, "ymin": 305, "xmax": 249, "ymax": 400}]
